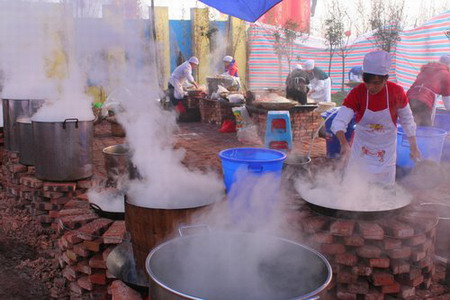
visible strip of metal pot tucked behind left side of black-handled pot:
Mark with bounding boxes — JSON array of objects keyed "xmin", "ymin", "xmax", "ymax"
[{"xmin": 16, "ymin": 118, "xmax": 35, "ymax": 166}]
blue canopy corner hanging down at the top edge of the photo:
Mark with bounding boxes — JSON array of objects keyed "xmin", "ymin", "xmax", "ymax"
[{"xmin": 200, "ymin": 0, "xmax": 282, "ymax": 22}]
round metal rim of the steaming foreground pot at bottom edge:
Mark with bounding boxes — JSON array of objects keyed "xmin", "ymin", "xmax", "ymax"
[{"xmin": 145, "ymin": 232, "xmax": 333, "ymax": 300}]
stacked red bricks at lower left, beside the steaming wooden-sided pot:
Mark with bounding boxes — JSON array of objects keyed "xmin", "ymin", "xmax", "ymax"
[{"xmin": 57, "ymin": 200, "xmax": 126, "ymax": 299}]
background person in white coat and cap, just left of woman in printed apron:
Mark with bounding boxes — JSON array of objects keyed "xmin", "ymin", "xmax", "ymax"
[{"xmin": 303, "ymin": 59, "xmax": 331, "ymax": 103}]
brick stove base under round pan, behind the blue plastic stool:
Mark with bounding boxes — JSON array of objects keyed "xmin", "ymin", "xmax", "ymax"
[{"xmin": 251, "ymin": 109, "xmax": 322, "ymax": 142}]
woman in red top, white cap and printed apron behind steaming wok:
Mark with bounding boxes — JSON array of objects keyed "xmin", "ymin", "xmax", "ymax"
[{"xmin": 331, "ymin": 50, "xmax": 420, "ymax": 186}]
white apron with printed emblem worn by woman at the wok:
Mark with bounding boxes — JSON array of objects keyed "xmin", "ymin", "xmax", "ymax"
[{"xmin": 347, "ymin": 86, "xmax": 397, "ymax": 186}]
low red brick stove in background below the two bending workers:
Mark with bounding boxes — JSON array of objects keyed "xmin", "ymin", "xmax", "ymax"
[{"xmin": 199, "ymin": 98, "xmax": 239, "ymax": 126}]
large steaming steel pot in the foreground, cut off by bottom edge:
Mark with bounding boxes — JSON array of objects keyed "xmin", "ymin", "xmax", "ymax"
[{"xmin": 146, "ymin": 232, "xmax": 332, "ymax": 300}]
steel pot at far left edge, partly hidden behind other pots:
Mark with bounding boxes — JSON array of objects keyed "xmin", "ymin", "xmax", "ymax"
[{"xmin": 2, "ymin": 99, "xmax": 44, "ymax": 152}]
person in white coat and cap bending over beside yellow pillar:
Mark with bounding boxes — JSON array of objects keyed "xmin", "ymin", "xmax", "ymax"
[{"xmin": 169, "ymin": 56, "xmax": 199, "ymax": 106}]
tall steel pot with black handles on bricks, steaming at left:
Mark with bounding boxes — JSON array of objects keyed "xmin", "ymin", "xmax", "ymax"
[{"xmin": 32, "ymin": 118, "xmax": 94, "ymax": 181}]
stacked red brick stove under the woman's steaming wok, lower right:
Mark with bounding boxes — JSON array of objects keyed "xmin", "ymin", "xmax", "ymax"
[{"xmin": 299, "ymin": 206, "xmax": 437, "ymax": 300}]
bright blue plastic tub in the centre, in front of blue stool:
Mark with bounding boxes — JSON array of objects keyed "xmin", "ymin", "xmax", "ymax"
[{"xmin": 219, "ymin": 148, "xmax": 286, "ymax": 192}]
